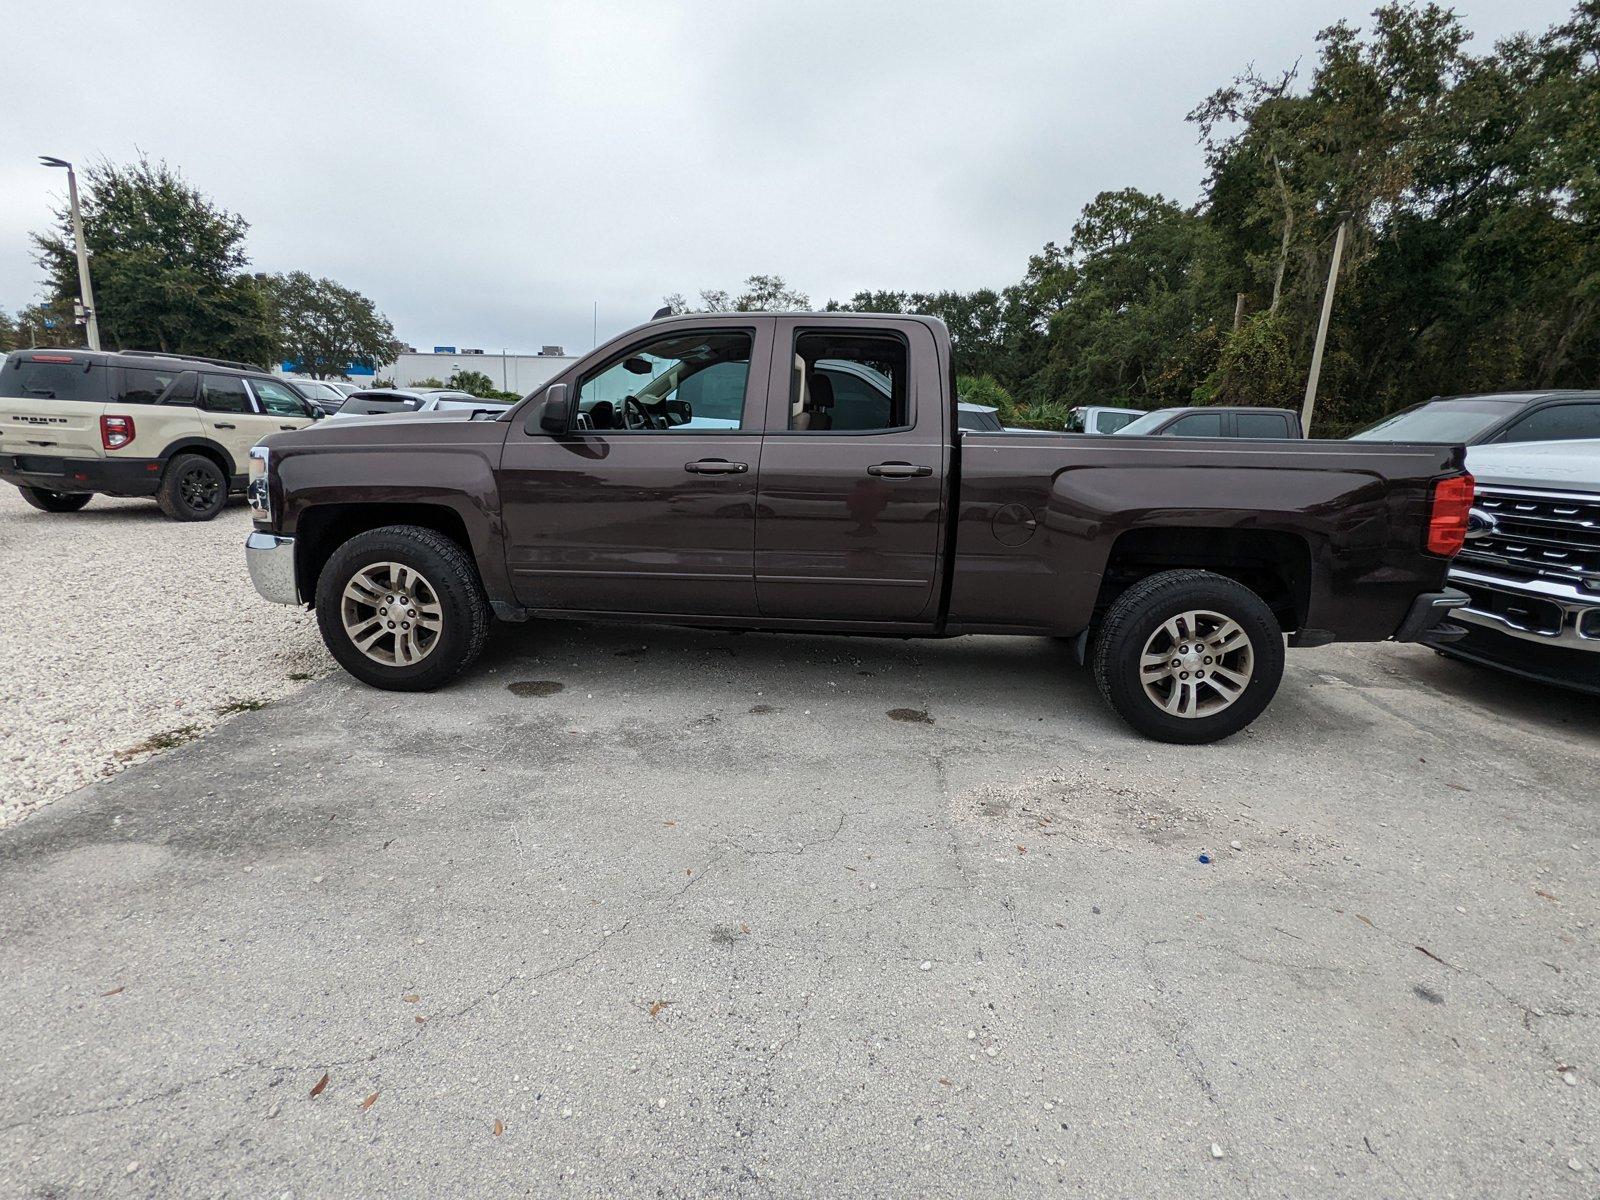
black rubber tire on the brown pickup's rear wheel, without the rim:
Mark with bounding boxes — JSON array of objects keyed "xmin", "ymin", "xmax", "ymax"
[{"xmin": 1094, "ymin": 571, "xmax": 1283, "ymax": 746}]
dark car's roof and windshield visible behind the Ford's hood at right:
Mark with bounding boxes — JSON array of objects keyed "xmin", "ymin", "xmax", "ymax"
[{"xmin": 1350, "ymin": 390, "xmax": 1600, "ymax": 446}]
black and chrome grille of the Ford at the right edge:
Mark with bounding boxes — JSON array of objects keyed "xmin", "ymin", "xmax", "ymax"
[{"xmin": 1458, "ymin": 486, "xmax": 1600, "ymax": 598}]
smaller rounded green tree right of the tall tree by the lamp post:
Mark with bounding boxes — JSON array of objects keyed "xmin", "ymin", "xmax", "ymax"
[{"xmin": 261, "ymin": 270, "xmax": 402, "ymax": 379}]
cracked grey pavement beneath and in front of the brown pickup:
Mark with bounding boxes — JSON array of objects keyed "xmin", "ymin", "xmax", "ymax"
[{"xmin": 0, "ymin": 624, "xmax": 1600, "ymax": 1197}]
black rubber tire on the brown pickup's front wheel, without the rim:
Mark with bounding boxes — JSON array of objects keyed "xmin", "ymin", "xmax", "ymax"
[{"xmin": 317, "ymin": 525, "xmax": 490, "ymax": 691}]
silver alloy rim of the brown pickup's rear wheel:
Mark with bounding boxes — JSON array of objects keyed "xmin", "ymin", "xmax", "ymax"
[{"xmin": 1139, "ymin": 610, "xmax": 1256, "ymax": 717}]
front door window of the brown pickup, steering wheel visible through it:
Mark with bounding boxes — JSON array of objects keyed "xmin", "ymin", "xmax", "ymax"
[{"xmin": 578, "ymin": 330, "xmax": 752, "ymax": 434}]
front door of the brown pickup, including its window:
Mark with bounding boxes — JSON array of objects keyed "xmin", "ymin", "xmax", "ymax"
[{"xmin": 499, "ymin": 318, "xmax": 771, "ymax": 616}]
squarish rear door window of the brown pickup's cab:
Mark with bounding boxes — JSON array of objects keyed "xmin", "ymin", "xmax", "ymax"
[{"xmin": 789, "ymin": 333, "xmax": 910, "ymax": 434}]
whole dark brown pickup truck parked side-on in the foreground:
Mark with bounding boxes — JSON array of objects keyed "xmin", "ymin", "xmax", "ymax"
[{"xmin": 246, "ymin": 314, "xmax": 1472, "ymax": 742}]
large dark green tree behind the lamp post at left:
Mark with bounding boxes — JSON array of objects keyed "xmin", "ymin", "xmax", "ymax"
[{"xmin": 32, "ymin": 158, "xmax": 277, "ymax": 362}]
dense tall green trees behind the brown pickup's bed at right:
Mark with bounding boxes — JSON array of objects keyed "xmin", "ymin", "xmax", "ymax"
[{"xmin": 829, "ymin": 0, "xmax": 1600, "ymax": 435}]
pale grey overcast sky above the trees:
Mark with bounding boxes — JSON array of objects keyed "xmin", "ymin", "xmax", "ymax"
[{"xmin": 0, "ymin": 0, "xmax": 1570, "ymax": 350}]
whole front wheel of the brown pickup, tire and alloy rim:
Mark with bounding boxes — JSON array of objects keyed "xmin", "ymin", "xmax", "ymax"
[{"xmin": 317, "ymin": 525, "xmax": 490, "ymax": 691}]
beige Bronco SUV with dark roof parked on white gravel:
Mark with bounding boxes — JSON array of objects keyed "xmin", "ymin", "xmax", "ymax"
[{"xmin": 0, "ymin": 350, "xmax": 322, "ymax": 522}]
